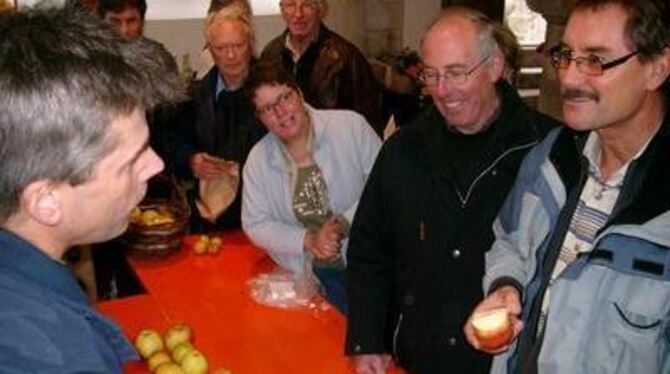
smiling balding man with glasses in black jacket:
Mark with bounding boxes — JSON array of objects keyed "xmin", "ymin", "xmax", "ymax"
[{"xmin": 346, "ymin": 8, "xmax": 554, "ymax": 374}]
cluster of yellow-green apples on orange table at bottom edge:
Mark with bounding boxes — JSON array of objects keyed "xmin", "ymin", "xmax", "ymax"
[{"xmin": 135, "ymin": 323, "xmax": 232, "ymax": 374}]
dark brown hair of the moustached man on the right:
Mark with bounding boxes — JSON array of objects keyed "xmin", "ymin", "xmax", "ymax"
[{"xmin": 572, "ymin": 0, "xmax": 670, "ymax": 97}]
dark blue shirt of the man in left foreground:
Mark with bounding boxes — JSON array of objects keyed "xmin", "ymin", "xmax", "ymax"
[{"xmin": 0, "ymin": 230, "xmax": 139, "ymax": 374}]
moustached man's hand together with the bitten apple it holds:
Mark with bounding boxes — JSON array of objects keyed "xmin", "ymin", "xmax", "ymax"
[{"xmin": 463, "ymin": 286, "xmax": 523, "ymax": 354}]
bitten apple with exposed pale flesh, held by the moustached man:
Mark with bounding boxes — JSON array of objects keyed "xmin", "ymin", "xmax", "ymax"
[{"xmin": 472, "ymin": 308, "xmax": 514, "ymax": 350}]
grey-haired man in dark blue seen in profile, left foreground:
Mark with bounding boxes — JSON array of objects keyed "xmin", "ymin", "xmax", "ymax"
[{"xmin": 0, "ymin": 2, "xmax": 181, "ymax": 373}]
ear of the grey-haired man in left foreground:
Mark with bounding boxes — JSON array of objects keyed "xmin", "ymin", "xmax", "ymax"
[{"xmin": 21, "ymin": 180, "xmax": 63, "ymax": 226}]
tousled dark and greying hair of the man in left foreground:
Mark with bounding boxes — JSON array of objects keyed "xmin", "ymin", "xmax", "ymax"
[{"xmin": 0, "ymin": 5, "xmax": 183, "ymax": 224}]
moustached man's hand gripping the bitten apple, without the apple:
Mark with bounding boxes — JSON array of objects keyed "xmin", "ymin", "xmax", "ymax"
[{"xmin": 463, "ymin": 286, "xmax": 523, "ymax": 354}]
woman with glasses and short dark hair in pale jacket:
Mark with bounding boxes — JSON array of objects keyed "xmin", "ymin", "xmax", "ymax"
[{"xmin": 242, "ymin": 63, "xmax": 381, "ymax": 313}]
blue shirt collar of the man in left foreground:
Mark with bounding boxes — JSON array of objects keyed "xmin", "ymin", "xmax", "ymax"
[{"xmin": 0, "ymin": 230, "xmax": 88, "ymax": 305}]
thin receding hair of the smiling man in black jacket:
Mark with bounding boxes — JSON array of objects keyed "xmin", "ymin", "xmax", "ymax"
[{"xmin": 421, "ymin": 6, "xmax": 500, "ymax": 58}]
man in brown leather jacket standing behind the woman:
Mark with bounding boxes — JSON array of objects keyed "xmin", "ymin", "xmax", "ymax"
[{"xmin": 261, "ymin": 0, "xmax": 386, "ymax": 136}]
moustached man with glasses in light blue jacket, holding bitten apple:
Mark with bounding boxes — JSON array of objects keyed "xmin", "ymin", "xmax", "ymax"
[{"xmin": 465, "ymin": 0, "xmax": 670, "ymax": 373}]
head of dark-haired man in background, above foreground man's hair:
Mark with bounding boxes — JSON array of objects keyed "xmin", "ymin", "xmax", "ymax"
[{"xmin": 98, "ymin": 0, "xmax": 147, "ymax": 38}]
